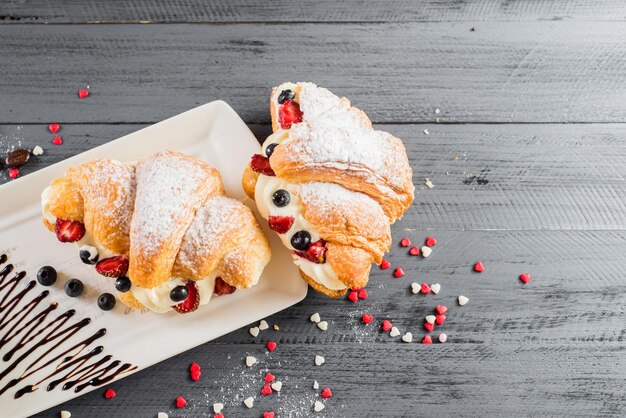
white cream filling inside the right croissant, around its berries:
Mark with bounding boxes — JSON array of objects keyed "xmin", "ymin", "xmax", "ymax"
[{"xmin": 254, "ymin": 129, "xmax": 347, "ymax": 290}]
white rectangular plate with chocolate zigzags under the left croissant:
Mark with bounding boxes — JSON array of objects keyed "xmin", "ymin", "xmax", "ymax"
[{"xmin": 0, "ymin": 101, "xmax": 307, "ymax": 417}]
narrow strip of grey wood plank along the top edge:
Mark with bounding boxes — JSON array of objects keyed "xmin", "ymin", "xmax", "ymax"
[{"xmin": 0, "ymin": 0, "xmax": 626, "ymax": 24}]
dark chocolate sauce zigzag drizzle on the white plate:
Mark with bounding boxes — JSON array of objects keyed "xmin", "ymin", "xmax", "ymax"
[{"xmin": 0, "ymin": 254, "xmax": 137, "ymax": 399}]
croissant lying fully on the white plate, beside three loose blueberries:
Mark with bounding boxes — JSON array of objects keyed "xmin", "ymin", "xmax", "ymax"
[{"xmin": 42, "ymin": 151, "xmax": 271, "ymax": 313}]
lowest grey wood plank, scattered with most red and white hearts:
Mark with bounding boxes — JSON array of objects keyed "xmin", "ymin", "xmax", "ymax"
[{"xmin": 30, "ymin": 228, "xmax": 626, "ymax": 418}]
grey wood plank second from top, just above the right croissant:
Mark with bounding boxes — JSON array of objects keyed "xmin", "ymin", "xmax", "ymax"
[{"xmin": 0, "ymin": 22, "xmax": 626, "ymax": 123}]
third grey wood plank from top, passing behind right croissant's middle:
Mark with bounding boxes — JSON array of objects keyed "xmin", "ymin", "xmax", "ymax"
[{"xmin": 0, "ymin": 124, "xmax": 626, "ymax": 230}]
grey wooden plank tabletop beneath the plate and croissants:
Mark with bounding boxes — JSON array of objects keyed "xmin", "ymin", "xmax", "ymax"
[{"xmin": 0, "ymin": 0, "xmax": 626, "ymax": 418}]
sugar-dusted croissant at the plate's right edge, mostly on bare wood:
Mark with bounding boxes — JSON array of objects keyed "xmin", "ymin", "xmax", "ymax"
[{"xmin": 242, "ymin": 83, "xmax": 415, "ymax": 298}]
